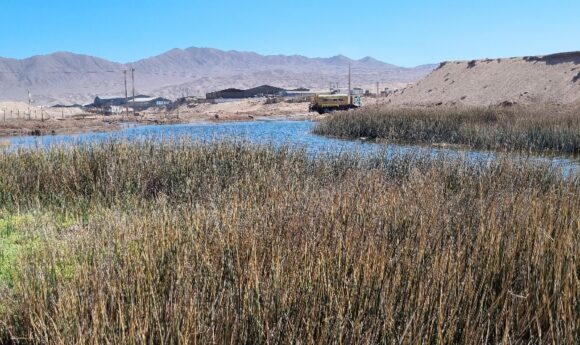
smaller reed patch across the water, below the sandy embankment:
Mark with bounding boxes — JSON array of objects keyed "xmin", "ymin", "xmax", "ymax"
[{"xmin": 315, "ymin": 107, "xmax": 580, "ymax": 155}]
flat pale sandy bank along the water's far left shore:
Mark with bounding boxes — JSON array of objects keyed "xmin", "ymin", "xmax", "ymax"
[{"xmin": 0, "ymin": 99, "xmax": 320, "ymax": 137}]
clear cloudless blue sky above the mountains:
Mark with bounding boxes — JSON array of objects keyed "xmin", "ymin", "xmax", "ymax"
[{"xmin": 0, "ymin": 0, "xmax": 580, "ymax": 66}]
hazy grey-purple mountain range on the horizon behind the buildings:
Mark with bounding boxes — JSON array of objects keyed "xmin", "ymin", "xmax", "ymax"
[{"xmin": 0, "ymin": 48, "xmax": 435, "ymax": 104}]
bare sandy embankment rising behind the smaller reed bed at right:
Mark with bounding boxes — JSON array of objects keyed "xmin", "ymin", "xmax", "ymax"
[{"xmin": 389, "ymin": 52, "xmax": 580, "ymax": 106}]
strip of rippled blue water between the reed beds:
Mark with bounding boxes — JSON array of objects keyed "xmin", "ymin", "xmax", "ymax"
[{"xmin": 8, "ymin": 121, "xmax": 580, "ymax": 172}]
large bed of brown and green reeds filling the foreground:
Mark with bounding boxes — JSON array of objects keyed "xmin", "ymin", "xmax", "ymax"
[{"xmin": 0, "ymin": 142, "xmax": 580, "ymax": 344}]
